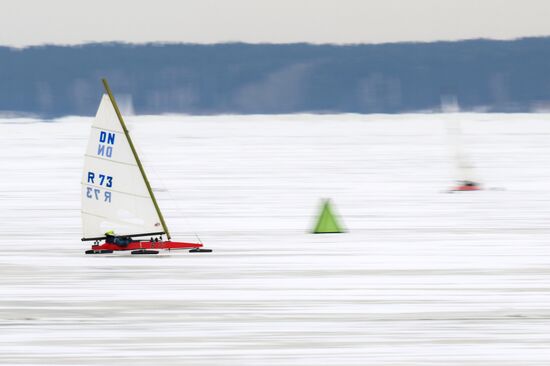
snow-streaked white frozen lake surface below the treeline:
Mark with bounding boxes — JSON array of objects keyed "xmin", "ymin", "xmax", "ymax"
[{"xmin": 0, "ymin": 114, "xmax": 550, "ymax": 366}]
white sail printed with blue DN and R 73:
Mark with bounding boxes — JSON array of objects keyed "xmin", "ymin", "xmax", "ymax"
[{"xmin": 82, "ymin": 94, "xmax": 164, "ymax": 238}]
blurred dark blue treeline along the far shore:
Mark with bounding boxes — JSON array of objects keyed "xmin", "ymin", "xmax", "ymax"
[{"xmin": 0, "ymin": 38, "xmax": 550, "ymax": 117}]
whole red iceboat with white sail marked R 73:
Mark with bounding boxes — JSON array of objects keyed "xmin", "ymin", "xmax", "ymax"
[{"xmin": 82, "ymin": 79, "xmax": 211, "ymax": 254}]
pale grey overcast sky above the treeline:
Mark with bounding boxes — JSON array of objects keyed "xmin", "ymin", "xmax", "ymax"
[{"xmin": 0, "ymin": 0, "xmax": 550, "ymax": 47}]
